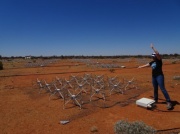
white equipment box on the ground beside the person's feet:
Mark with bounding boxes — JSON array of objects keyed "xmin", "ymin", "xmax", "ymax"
[{"xmin": 136, "ymin": 98, "xmax": 155, "ymax": 109}]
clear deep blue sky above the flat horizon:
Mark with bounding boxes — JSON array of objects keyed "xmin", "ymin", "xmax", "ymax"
[{"xmin": 0, "ymin": 0, "xmax": 180, "ymax": 56}]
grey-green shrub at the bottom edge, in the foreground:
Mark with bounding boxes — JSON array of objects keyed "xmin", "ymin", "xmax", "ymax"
[{"xmin": 114, "ymin": 120, "xmax": 156, "ymax": 134}]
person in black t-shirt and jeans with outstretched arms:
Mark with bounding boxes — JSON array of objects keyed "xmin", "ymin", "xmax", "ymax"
[{"xmin": 138, "ymin": 44, "xmax": 172, "ymax": 110}]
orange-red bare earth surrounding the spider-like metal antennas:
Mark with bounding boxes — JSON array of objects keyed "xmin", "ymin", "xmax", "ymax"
[{"xmin": 0, "ymin": 58, "xmax": 180, "ymax": 134}]
